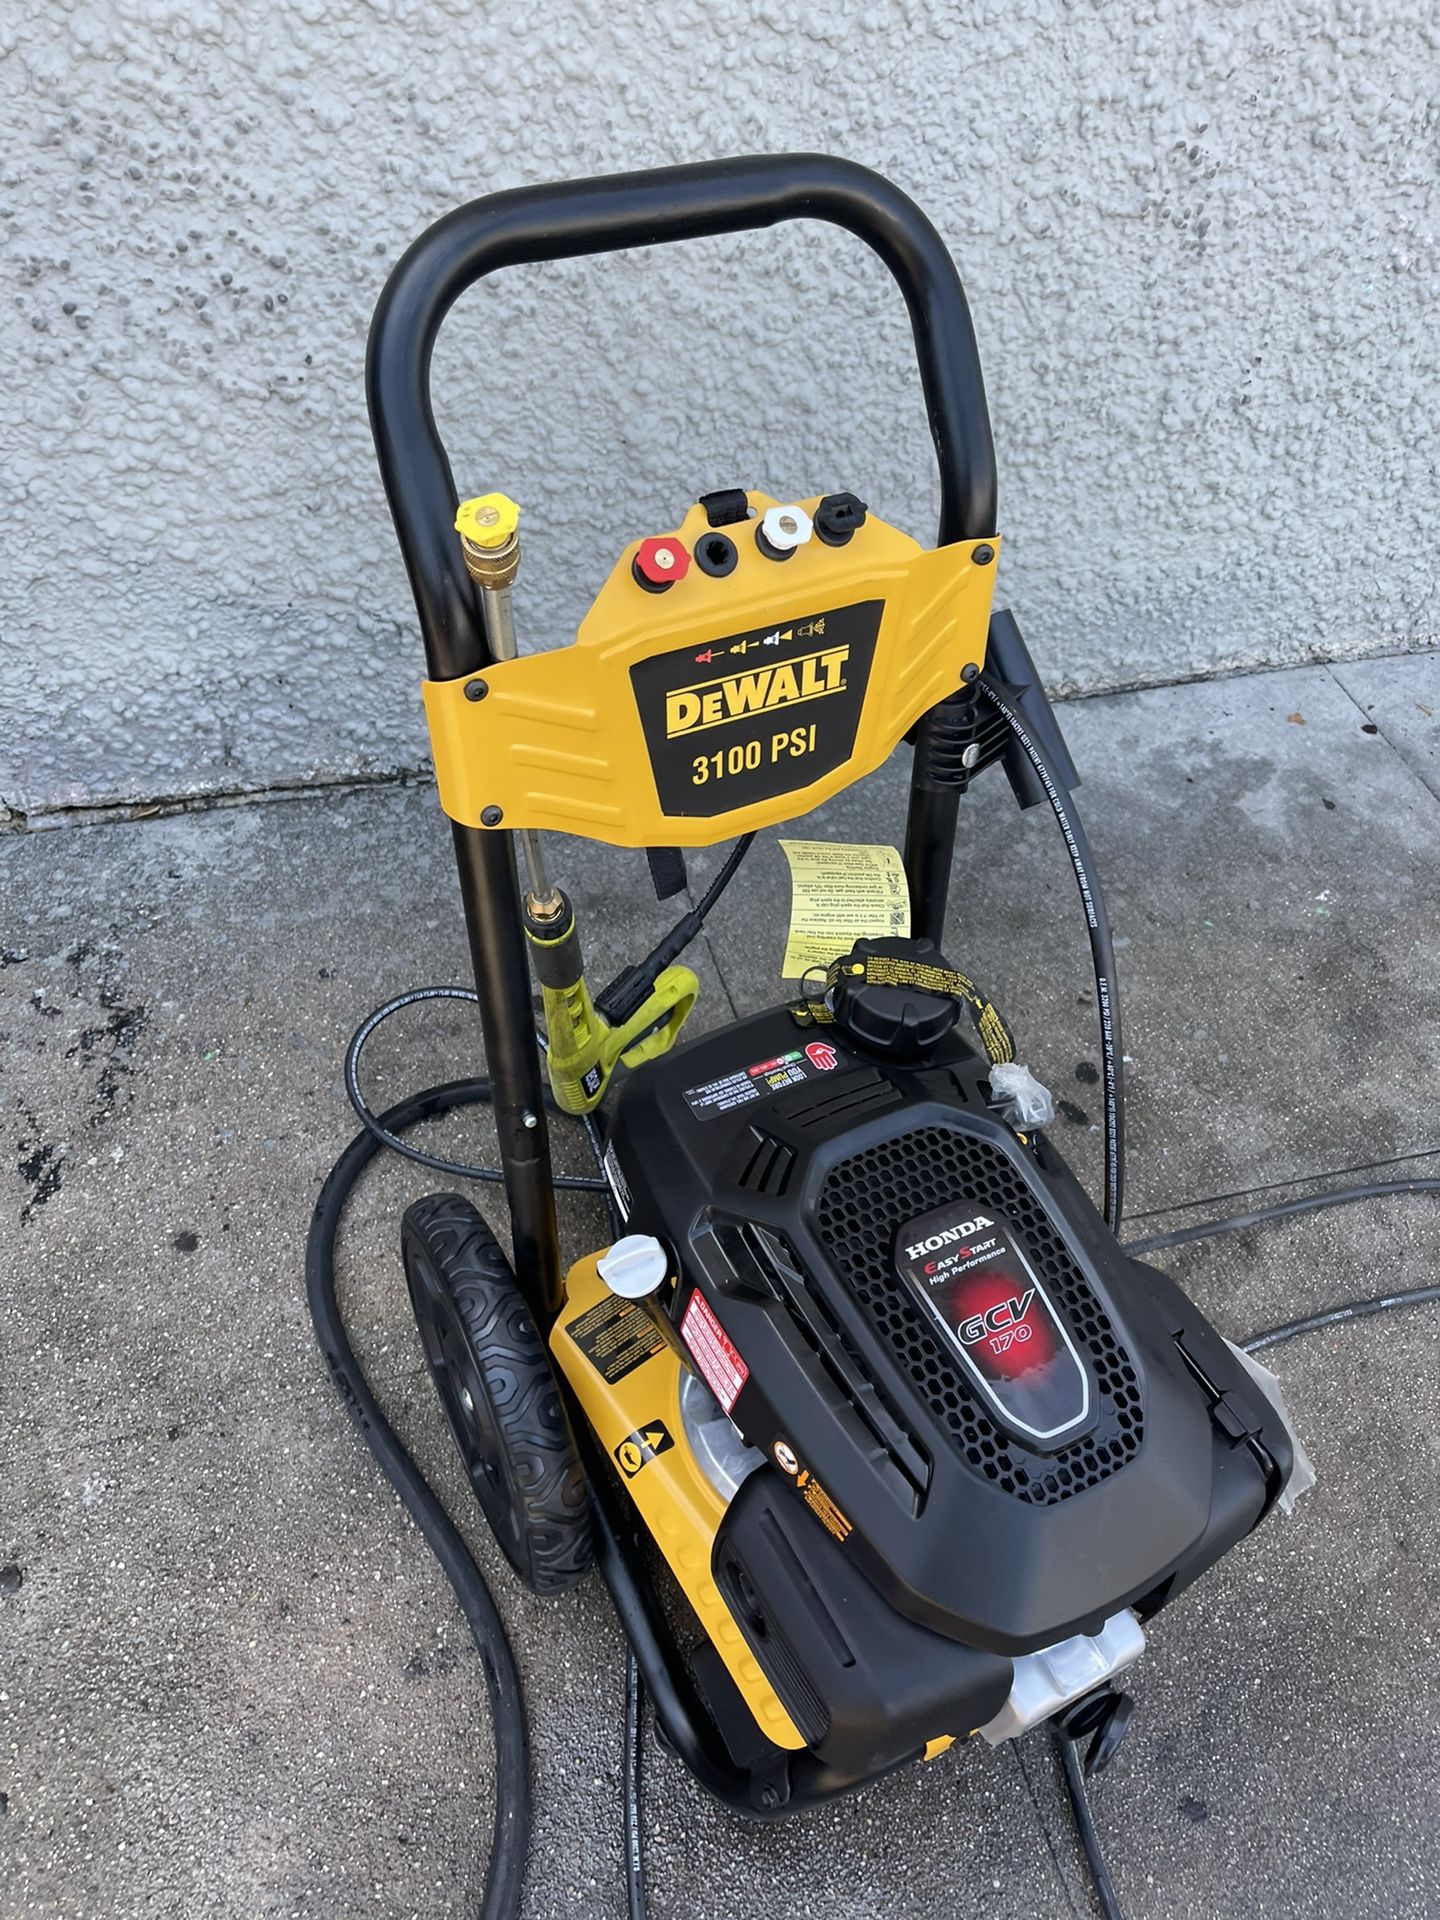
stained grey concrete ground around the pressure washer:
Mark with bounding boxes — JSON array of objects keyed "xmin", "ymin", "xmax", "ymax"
[{"xmin": 0, "ymin": 657, "xmax": 1440, "ymax": 1920}]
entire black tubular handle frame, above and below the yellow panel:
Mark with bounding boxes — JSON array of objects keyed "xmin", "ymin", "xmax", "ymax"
[{"xmin": 365, "ymin": 154, "xmax": 996, "ymax": 1331}]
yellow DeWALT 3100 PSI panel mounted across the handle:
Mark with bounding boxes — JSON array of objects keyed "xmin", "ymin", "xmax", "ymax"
[{"xmin": 424, "ymin": 493, "xmax": 998, "ymax": 847}]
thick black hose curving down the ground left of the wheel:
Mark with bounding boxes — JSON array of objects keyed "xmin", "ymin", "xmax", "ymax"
[{"xmin": 305, "ymin": 1079, "xmax": 530, "ymax": 1920}]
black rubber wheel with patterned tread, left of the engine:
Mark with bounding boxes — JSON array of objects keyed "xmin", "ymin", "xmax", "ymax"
[{"xmin": 401, "ymin": 1194, "xmax": 591, "ymax": 1594}]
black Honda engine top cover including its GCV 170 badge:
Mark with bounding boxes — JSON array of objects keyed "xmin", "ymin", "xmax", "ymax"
[{"xmin": 607, "ymin": 983, "xmax": 1292, "ymax": 1658}]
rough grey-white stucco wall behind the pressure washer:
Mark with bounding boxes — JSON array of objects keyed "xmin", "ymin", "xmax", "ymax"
[{"xmin": 0, "ymin": 0, "xmax": 1440, "ymax": 816}]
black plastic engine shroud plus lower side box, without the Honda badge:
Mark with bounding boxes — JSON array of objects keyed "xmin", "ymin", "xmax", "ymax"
[{"xmin": 611, "ymin": 1008, "xmax": 1292, "ymax": 1795}]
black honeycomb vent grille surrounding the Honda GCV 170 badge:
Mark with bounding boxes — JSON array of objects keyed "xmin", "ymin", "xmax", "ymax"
[{"xmin": 816, "ymin": 1127, "xmax": 1144, "ymax": 1507}]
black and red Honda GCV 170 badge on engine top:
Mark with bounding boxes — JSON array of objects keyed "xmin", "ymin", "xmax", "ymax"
[{"xmin": 895, "ymin": 1200, "xmax": 1091, "ymax": 1440}]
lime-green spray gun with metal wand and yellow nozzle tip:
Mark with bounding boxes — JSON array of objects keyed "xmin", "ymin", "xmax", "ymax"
[{"xmin": 455, "ymin": 493, "xmax": 699, "ymax": 1114}]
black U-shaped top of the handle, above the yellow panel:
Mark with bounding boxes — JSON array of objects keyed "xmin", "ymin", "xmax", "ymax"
[{"xmin": 367, "ymin": 154, "xmax": 995, "ymax": 678}]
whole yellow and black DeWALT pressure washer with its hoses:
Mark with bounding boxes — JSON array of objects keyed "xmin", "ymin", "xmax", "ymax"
[{"xmin": 309, "ymin": 156, "xmax": 1434, "ymax": 1914}]
